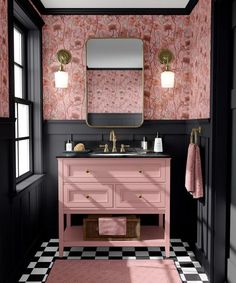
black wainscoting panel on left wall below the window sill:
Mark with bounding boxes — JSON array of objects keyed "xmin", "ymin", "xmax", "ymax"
[{"xmin": 10, "ymin": 184, "xmax": 43, "ymax": 282}]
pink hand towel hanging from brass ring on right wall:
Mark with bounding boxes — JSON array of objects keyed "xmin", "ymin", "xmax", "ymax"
[{"xmin": 185, "ymin": 143, "xmax": 203, "ymax": 198}]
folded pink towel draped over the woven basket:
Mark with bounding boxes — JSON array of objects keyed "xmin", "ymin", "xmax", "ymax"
[{"xmin": 98, "ymin": 217, "xmax": 126, "ymax": 236}]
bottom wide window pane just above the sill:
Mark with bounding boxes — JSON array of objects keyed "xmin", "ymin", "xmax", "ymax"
[{"xmin": 18, "ymin": 140, "xmax": 30, "ymax": 176}]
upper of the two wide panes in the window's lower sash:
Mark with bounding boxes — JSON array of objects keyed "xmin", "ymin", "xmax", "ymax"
[{"xmin": 18, "ymin": 103, "xmax": 29, "ymax": 138}]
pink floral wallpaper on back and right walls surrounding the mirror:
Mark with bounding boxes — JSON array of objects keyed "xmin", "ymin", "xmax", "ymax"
[{"xmin": 43, "ymin": 0, "xmax": 211, "ymax": 120}]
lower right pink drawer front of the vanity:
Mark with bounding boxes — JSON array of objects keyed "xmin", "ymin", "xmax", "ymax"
[{"xmin": 115, "ymin": 183, "xmax": 165, "ymax": 208}]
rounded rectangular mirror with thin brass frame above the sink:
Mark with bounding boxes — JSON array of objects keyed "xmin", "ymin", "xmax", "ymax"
[{"xmin": 86, "ymin": 38, "xmax": 143, "ymax": 127}]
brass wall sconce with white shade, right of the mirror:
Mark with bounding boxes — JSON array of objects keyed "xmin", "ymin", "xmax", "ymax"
[{"xmin": 158, "ymin": 49, "xmax": 175, "ymax": 88}]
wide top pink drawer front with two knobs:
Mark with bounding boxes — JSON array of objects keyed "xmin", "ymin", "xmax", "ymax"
[{"xmin": 64, "ymin": 158, "xmax": 166, "ymax": 182}]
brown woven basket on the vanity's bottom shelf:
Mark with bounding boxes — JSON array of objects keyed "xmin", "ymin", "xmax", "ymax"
[{"xmin": 83, "ymin": 215, "xmax": 140, "ymax": 241}]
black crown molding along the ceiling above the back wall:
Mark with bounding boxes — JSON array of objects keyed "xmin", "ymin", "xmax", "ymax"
[{"xmin": 31, "ymin": 0, "xmax": 198, "ymax": 15}]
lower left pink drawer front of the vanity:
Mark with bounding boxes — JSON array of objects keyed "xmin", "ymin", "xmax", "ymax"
[{"xmin": 64, "ymin": 183, "xmax": 113, "ymax": 208}]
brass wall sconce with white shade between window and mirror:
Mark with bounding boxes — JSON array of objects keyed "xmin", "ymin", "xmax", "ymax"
[{"xmin": 55, "ymin": 49, "xmax": 71, "ymax": 88}]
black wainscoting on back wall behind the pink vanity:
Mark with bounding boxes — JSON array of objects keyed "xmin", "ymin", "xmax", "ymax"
[{"xmin": 44, "ymin": 120, "xmax": 209, "ymax": 246}]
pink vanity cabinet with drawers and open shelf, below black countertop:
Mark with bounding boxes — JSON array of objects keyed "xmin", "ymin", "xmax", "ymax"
[{"xmin": 58, "ymin": 157, "xmax": 170, "ymax": 257}]
